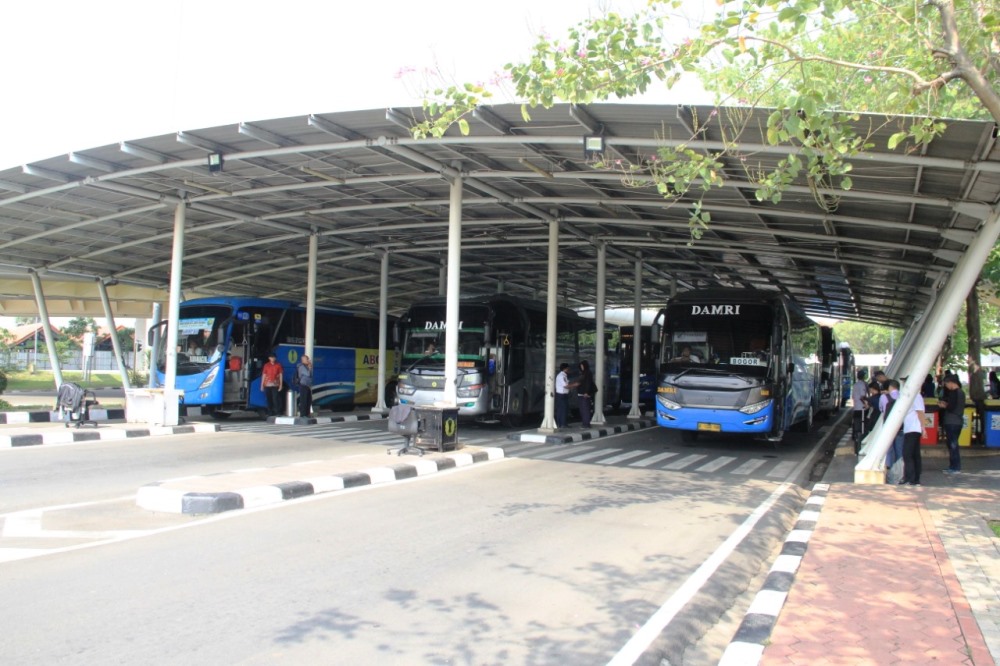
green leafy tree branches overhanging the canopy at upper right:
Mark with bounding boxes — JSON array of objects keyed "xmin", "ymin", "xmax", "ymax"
[{"xmin": 413, "ymin": 0, "xmax": 1000, "ymax": 244}]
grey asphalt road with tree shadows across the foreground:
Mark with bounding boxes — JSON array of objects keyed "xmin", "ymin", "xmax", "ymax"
[{"xmin": 0, "ymin": 416, "xmax": 832, "ymax": 664}]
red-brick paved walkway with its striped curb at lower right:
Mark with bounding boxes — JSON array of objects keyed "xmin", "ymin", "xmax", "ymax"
[{"xmin": 720, "ymin": 430, "xmax": 1000, "ymax": 666}]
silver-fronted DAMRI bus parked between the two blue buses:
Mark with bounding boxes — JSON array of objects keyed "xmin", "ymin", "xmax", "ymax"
[{"xmin": 396, "ymin": 294, "xmax": 617, "ymax": 427}]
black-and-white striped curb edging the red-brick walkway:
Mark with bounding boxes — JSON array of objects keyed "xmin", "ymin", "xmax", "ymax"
[{"xmin": 719, "ymin": 483, "xmax": 830, "ymax": 666}]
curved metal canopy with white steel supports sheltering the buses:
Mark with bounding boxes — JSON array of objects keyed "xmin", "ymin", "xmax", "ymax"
[{"xmin": 0, "ymin": 104, "xmax": 1000, "ymax": 480}]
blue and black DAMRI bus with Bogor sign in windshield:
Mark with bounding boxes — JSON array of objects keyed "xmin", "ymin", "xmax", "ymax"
[{"xmin": 656, "ymin": 289, "xmax": 821, "ymax": 441}]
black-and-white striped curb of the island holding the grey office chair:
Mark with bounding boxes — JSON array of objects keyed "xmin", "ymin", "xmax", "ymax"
[{"xmin": 136, "ymin": 447, "xmax": 504, "ymax": 514}]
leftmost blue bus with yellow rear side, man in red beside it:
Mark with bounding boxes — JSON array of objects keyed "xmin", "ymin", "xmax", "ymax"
[{"xmin": 154, "ymin": 296, "xmax": 395, "ymax": 418}]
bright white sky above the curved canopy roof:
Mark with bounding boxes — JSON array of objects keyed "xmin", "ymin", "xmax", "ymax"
[{"xmin": 0, "ymin": 0, "xmax": 712, "ymax": 169}]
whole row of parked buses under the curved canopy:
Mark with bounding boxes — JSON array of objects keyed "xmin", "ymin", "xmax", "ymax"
[{"xmin": 155, "ymin": 289, "xmax": 853, "ymax": 441}]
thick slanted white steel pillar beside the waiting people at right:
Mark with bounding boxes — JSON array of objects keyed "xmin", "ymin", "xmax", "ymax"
[{"xmin": 854, "ymin": 209, "xmax": 1000, "ymax": 483}]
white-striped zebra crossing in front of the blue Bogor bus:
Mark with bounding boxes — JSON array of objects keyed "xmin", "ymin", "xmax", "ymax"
[{"xmin": 504, "ymin": 443, "xmax": 799, "ymax": 479}]
